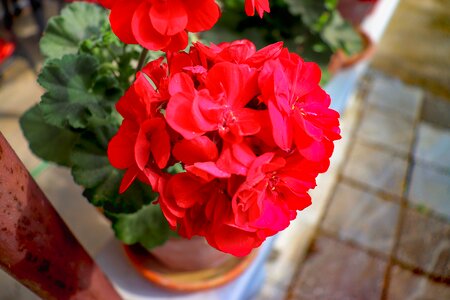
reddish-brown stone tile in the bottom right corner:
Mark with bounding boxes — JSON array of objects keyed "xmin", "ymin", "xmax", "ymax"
[{"xmin": 387, "ymin": 266, "xmax": 450, "ymax": 300}]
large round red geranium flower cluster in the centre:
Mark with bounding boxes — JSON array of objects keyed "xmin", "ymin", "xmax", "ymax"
[{"xmin": 108, "ymin": 40, "xmax": 340, "ymax": 256}]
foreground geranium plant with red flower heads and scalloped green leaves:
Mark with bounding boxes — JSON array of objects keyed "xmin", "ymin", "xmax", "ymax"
[{"xmin": 20, "ymin": 0, "xmax": 340, "ymax": 287}]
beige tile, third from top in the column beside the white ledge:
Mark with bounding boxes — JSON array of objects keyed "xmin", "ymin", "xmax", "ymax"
[{"xmin": 343, "ymin": 140, "xmax": 408, "ymax": 197}]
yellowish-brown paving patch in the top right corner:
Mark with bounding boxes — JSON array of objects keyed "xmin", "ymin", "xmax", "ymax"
[{"xmin": 373, "ymin": 0, "xmax": 450, "ymax": 98}]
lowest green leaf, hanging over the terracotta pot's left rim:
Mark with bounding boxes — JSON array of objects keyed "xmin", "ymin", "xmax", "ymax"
[{"xmin": 107, "ymin": 204, "xmax": 173, "ymax": 249}]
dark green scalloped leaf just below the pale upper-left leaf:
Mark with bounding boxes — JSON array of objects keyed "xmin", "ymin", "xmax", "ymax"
[{"xmin": 38, "ymin": 54, "xmax": 121, "ymax": 128}]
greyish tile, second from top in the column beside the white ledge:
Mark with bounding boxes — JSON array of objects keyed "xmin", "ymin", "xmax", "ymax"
[{"xmin": 357, "ymin": 107, "xmax": 414, "ymax": 154}]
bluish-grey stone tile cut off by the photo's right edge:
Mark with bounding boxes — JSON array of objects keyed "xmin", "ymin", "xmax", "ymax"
[{"xmin": 414, "ymin": 122, "xmax": 450, "ymax": 172}]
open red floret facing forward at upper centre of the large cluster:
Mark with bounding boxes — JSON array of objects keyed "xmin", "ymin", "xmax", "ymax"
[{"xmin": 166, "ymin": 63, "xmax": 260, "ymax": 142}]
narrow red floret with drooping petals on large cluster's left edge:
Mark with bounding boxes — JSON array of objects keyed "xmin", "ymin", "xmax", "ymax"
[{"xmin": 108, "ymin": 75, "xmax": 170, "ymax": 193}]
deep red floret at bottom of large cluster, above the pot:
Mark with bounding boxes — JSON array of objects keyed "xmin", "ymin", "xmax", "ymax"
[{"xmin": 159, "ymin": 173, "xmax": 267, "ymax": 256}]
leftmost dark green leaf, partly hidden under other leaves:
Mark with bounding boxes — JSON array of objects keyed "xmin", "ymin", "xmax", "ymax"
[{"xmin": 20, "ymin": 104, "xmax": 79, "ymax": 166}]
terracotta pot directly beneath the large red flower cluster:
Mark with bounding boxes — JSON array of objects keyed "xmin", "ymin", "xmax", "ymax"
[{"xmin": 125, "ymin": 237, "xmax": 256, "ymax": 291}]
